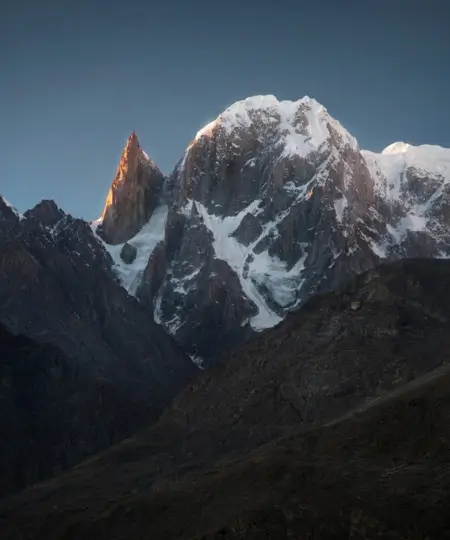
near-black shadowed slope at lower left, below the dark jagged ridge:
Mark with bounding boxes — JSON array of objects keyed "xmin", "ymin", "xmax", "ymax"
[{"xmin": 0, "ymin": 325, "xmax": 176, "ymax": 497}]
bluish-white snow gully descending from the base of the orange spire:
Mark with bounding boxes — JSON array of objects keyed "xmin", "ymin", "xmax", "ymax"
[{"xmin": 92, "ymin": 206, "xmax": 168, "ymax": 295}]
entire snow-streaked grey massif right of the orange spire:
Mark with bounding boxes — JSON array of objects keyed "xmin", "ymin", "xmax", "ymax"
[{"xmin": 94, "ymin": 96, "xmax": 450, "ymax": 364}]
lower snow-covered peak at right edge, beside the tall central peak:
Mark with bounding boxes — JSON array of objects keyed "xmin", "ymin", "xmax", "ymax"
[{"xmin": 362, "ymin": 142, "xmax": 450, "ymax": 257}]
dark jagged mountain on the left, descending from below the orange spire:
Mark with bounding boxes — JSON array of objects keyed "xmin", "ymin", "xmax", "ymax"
[{"xmin": 0, "ymin": 193, "xmax": 197, "ymax": 489}]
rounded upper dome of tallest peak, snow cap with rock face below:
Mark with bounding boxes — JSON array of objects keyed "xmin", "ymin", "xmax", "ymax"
[{"xmin": 170, "ymin": 95, "xmax": 358, "ymax": 215}]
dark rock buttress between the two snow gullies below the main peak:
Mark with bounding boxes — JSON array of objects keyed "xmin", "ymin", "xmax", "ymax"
[{"xmin": 137, "ymin": 205, "xmax": 257, "ymax": 361}]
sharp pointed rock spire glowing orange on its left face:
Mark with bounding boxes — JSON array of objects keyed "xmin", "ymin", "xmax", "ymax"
[{"xmin": 97, "ymin": 131, "xmax": 164, "ymax": 244}]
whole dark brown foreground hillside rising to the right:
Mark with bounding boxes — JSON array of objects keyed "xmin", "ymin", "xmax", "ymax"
[{"xmin": 0, "ymin": 260, "xmax": 450, "ymax": 540}]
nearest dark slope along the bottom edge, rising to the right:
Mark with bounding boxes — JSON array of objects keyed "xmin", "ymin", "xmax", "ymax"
[{"xmin": 9, "ymin": 358, "xmax": 450, "ymax": 540}]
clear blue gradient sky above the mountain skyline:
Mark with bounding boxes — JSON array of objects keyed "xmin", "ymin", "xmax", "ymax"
[{"xmin": 0, "ymin": 0, "xmax": 450, "ymax": 219}]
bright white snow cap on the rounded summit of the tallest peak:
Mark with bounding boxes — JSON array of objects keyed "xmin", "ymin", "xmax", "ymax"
[{"xmin": 195, "ymin": 95, "xmax": 358, "ymax": 157}]
